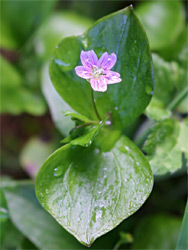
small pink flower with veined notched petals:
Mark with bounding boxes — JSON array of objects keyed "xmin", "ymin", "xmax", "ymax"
[{"xmin": 75, "ymin": 50, "xmax": 121, "ymax": 92}]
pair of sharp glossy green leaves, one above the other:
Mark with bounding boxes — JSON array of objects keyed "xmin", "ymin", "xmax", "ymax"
[{"xmin": 36, "ymin": 7, "xmax": 154, "ymax": 246}]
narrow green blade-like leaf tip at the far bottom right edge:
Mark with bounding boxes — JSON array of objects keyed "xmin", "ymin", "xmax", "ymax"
[{"xmin": 176, "ymin": 202, "xmax": 188, "ymax": 250}]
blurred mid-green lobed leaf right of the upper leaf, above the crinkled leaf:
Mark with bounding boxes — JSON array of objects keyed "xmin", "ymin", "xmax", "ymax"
[{"xmin": 146, "ymin": 51, "xmax": 188, "ymax": 121}]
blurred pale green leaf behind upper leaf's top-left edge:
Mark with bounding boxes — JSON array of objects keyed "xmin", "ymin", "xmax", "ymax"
[{"xmin": 34, "ymin": 11, "xmax": 93, "ymax": 61}]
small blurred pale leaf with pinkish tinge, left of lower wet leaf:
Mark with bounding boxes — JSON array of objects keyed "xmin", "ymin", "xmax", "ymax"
[{"xmin": 20, "ymin": 137, "xmax": 57, "ymax": 178}]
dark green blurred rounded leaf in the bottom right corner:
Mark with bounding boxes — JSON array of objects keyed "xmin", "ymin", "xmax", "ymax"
[{"xmin": 132, "ymin": 214, "xmax": 181, "ymax": 250}]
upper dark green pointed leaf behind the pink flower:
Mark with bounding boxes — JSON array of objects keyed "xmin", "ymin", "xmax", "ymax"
[{"xmin": 50, "ymin": 7, "xmax": 154, "ymax": 129}]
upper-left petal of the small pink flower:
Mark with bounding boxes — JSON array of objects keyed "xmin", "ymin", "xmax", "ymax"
[{"xmin": 80, "ymin": 50, "xmax": 98, "ymax": 68}]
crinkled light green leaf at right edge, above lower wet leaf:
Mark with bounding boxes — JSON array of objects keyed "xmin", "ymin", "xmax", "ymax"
[{"xmin": 144, "ymin": 119, "xmax": 188, "ymax": 175}]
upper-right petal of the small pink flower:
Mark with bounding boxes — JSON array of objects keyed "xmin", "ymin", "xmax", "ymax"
[{"xmin": 97, "ymin": 52, "xmax": 117, "ymax": 70}]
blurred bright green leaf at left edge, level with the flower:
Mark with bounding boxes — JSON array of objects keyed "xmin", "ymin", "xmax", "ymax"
[{"xmin": 0, "ymin": 57, "xmax": 46, "ymax": 115}]
